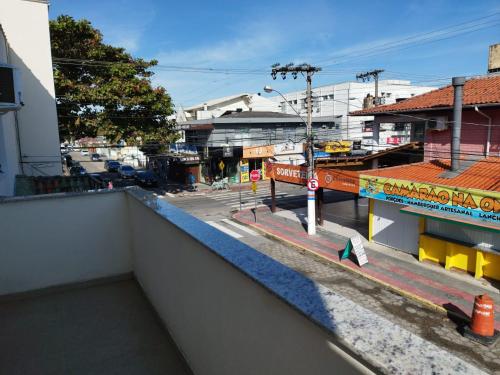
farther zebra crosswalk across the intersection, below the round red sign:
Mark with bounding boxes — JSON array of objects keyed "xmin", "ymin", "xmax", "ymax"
[{"xmin": 207, "ymin": 189, "xmax": 304, "ymax": 209}]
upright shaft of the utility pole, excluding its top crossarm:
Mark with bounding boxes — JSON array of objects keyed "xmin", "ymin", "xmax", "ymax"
[{"xmin": 307, "ymin": 72, "xmax": 316, "ymax": 236}]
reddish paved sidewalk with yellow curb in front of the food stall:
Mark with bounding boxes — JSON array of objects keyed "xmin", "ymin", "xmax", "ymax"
[{"xmin": 233, "ymin": 207, "xmax": 500, "ymax": 330}]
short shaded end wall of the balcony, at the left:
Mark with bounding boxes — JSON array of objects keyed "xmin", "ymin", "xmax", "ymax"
[{"xmin": 0, "ymin": 193, "xmax": 132, "ymax": 295}]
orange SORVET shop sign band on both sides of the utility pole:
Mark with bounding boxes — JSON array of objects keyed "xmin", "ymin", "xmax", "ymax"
[{"xmin": 266, "ymin": 162, "xmax": 359, "ymax": 194}]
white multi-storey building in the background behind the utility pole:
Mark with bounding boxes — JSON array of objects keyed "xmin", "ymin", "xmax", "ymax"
[{"xmin": 269, "ymin": 80, "xmax": 436, "ymax": 151}]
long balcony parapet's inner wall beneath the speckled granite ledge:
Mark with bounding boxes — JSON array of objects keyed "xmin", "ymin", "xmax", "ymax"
[{"xmin": 129, "ymin": 197, "xmax": 370, "ymax": 375}]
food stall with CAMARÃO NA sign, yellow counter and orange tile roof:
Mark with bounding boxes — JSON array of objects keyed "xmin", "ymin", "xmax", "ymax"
[{"xmin": 360, "ymin": 158, "xmax": 500, "ymax": 280}]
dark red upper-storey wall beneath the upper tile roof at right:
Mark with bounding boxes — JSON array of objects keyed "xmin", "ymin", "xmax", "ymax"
[{"xmin": 424, "ymin": 108, "xmax": 500, "ymax": 161}]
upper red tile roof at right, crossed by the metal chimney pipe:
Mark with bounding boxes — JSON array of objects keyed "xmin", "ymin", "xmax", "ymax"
[{"xmin": 351, "ymin": 75, "xmax": 500, "ymax": 116}]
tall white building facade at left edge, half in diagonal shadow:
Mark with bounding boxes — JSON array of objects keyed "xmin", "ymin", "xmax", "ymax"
[{"xmin": 0, "ymin": 0, "xmax": 62, "ymax": 196}]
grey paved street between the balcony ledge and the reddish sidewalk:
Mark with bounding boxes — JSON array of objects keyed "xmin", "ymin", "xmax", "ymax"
[{"xmin": 165, "ymin": 183, "xmax": 500, "ymax": 373}]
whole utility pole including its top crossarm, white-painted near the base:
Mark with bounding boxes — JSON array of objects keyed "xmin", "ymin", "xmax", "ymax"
[{"xmin": 271, "ymin": 64, "xmax": 321, "ymax": 235}]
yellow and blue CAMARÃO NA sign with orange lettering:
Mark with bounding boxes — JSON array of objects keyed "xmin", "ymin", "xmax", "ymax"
[{"xmin": 359, "ymin": 175, "xmax": 500, "ymax": 223}]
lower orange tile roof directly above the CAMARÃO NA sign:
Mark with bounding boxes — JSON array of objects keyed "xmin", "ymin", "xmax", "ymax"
[{"xmin": 360, "ymin": 157, "xmax": 500, "ymax": 192}]
